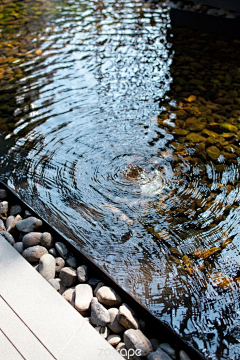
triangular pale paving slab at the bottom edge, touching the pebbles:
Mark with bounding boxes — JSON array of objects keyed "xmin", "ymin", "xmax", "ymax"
[{"xmin": 58, "ymin": 321, "xmax": 123, "ymax": 360}]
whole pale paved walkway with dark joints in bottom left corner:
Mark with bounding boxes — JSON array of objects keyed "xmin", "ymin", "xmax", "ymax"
[{"xmin": 0, "ymin": 237, "xmax": 123, "ymax": 360}]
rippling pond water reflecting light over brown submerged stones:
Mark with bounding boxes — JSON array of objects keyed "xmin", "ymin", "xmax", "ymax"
[{"xmin": 0, "ymin": 0, "xmax": 240, "ymax": 359}]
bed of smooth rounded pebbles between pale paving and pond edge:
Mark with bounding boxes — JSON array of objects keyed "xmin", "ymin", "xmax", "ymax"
[{"xmin": 0, "ymin": 189, "xmax": 190, "ymax": 360}]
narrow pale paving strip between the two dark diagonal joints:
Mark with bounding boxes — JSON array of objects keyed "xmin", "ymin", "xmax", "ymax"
[{"xmin": 0, "ymin": 297, "xmax": 54, "ymax": 360}]
